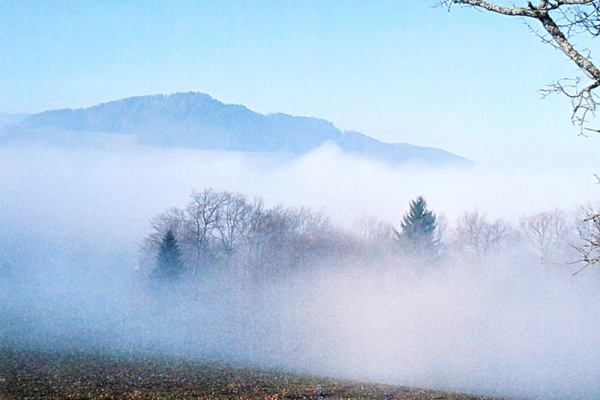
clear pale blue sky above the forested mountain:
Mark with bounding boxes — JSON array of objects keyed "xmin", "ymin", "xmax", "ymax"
[{"xmin": 0, "ymin": 0, "xmax": 600, "ymax": 164}]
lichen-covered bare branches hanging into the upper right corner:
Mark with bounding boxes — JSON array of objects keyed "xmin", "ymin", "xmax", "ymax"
[{"xmin": 438, "ymin": 0, "xmax": 600, "ymax": 133}]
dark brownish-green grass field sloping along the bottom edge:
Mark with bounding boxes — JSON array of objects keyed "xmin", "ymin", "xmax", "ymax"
[{"xmin": 0, "ymin": 349, "xmax": 504, "ymax": 400}]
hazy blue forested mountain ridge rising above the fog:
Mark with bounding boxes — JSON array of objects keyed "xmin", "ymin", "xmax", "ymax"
[{"xmin": 0, "ymin": 92, "xmax": 470, "ymax": 165}]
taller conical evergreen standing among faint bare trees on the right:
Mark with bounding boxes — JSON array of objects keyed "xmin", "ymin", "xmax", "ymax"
[{"xmin": 396, "ymin": 196, "xmax": 437, "ymax": 255}]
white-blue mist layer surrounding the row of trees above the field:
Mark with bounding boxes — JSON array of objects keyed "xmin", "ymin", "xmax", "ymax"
[{"xmin": 0, "ymin": 142, "xmax": 600, "ymax": 398}]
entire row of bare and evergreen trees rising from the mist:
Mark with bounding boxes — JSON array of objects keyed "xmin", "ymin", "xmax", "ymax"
[{"xmin": 144, "ymin": 189, "xmax": 600, "ymax": 280}]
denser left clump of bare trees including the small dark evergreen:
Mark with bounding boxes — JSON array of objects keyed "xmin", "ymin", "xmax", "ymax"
[{"xmin": 143, "ymin": 189, "xmax": 344, "ymax": 277}]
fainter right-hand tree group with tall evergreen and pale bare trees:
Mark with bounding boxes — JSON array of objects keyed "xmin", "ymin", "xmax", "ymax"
[{"xmin": 380, "ymin": 196, "xmax": 580, "ymax": 265}]
